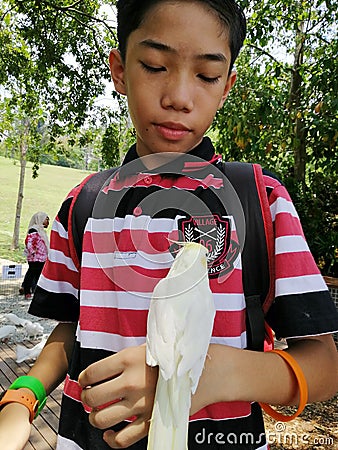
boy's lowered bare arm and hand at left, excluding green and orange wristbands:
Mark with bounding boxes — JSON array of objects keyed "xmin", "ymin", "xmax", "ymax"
[{"xmin": 0, "ymin": 323, "xmax": 76, "ymax": 450}]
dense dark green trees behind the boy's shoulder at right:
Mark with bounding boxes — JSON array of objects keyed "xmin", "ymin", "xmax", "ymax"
[{"xmin": 215, "ymin": 0, "xmax": 338, "ymax": 273}]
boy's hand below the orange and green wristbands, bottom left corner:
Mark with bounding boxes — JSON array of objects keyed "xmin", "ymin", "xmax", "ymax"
[{"xmin": 0, "ymin": 403, "xmax": 31, "ymax": 450}]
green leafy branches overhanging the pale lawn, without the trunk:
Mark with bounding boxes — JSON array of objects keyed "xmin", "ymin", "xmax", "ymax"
[{"xmin": 0, "ymin": 0, "xmax": 115, "ymax": 127}]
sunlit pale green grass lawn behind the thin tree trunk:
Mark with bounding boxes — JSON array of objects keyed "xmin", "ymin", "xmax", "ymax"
[{"xmin": 0, "ymin": 157, "xmax": 89, "ymax": 263}]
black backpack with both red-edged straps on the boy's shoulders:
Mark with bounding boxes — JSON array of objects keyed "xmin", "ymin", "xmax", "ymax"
[{"xmin": 68, "ymin": 162, "xmax": 274, "ymax": 351}]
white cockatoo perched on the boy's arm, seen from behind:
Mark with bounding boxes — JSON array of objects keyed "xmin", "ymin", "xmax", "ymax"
[{"xmin": 146, "ymin": 242, "xmax": 215, "ymax": 450}]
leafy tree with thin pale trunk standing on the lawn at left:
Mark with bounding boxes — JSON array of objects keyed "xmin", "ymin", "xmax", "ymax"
[{"xmin": 0, "ymin": 0, "xmax": 120, "ymax": 247}]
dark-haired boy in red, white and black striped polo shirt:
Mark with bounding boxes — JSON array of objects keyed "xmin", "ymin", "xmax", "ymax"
[{"xmin": 0, "ymin": 0, "xmax": 338, "ymax": 450}]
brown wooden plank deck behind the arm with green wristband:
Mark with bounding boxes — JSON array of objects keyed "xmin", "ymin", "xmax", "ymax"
[{"xmin": 0, "ymin": 341, "xmax": 62, "ymax": 450}]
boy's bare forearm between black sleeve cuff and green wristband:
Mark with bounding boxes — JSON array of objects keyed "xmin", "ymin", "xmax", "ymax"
[{"xmin": 28, "ymin": 323, "xmax": 76, "ymax": 395}]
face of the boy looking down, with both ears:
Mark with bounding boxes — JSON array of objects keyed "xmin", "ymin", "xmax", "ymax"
[{"xmin": 110, "ymin": 1, "xmax": 236, "ymax": 156}]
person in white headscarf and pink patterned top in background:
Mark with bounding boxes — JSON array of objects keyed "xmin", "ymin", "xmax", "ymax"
[{"xmin": 22, "ymin": 211, "xmax": 49, "ymax": 299}]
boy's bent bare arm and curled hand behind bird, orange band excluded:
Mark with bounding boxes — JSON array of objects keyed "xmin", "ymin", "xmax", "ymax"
[{"xmin": 79, "ymin": 335, "xmax": 338, "ymax": 448}]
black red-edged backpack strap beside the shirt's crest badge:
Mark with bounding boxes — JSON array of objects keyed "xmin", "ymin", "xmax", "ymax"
[{"xmin": 223, "ymin": 162, "xmax": 274, "ymax": 350}]
